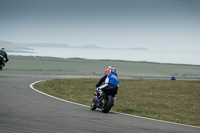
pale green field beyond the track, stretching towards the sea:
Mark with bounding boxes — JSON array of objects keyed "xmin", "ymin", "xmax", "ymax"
[{"xmin": 2, "ymin": 56, "xmax": 200, "ymax": 80}]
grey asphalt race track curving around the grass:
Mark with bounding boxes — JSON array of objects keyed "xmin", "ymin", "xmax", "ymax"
[{"xmin": 0, "ymin": 73, "xmax": 200, "ymax": 133}]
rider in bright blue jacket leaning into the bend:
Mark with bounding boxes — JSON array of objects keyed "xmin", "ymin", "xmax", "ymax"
[{"xmin": 96, "ymin": 68, "xmax": 119, "ymax": 97}]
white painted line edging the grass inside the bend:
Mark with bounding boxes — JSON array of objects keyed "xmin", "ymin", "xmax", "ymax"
[{"xmin": 30, "ymin": 80, "xmax": 200, "ymax": 129}]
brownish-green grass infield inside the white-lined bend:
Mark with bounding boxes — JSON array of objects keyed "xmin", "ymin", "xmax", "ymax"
[{"xmin": 34, "ymin": 78, "xmax": 200, "ymax": 126}]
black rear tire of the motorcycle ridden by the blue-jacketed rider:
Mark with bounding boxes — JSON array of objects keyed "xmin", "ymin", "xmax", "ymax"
[{"xmin": 101, "ymin": 95, "xmax": 114, "ymax": 113}]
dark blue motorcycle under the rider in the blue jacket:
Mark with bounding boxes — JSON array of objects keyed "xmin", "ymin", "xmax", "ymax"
[{"xmin": 90, "ymin": 87, "xmax": 117, "ymax": 113}]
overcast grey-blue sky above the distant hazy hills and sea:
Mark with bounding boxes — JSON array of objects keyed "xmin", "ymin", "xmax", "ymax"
[{"xmin": 0, "ymin": 0, "xmax": 200, "ymax": 50}]
